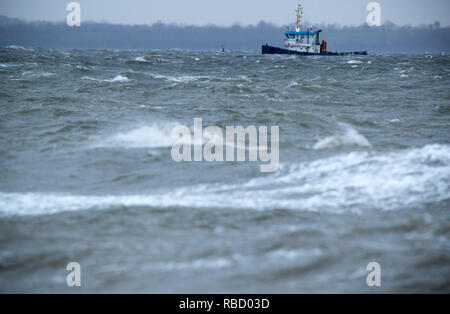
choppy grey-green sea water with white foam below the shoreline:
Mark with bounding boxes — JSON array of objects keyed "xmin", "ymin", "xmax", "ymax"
[{"xmin": 0, "ymin": 47, "xmax": 450, "ymax": 293}]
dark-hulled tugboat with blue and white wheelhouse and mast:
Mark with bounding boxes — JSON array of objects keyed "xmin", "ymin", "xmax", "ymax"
[{"xmin": 262, "ymin": 5, "xmax": 367, "ymax": 56}]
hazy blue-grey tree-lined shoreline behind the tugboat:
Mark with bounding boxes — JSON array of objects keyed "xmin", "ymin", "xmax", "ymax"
[{"xmin": 0, "ymin": 16, "xmax": 450, "ymax": 53}]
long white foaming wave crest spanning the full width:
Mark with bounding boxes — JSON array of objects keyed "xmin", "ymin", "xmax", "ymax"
[{"xmin": 0, "ymin": 144, "xmax": 450, "ymax": 215}]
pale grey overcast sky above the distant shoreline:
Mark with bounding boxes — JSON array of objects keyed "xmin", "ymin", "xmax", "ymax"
[{"xmin": 0, "ymin": 0, "xmax": 450, "ymax": 25}]
